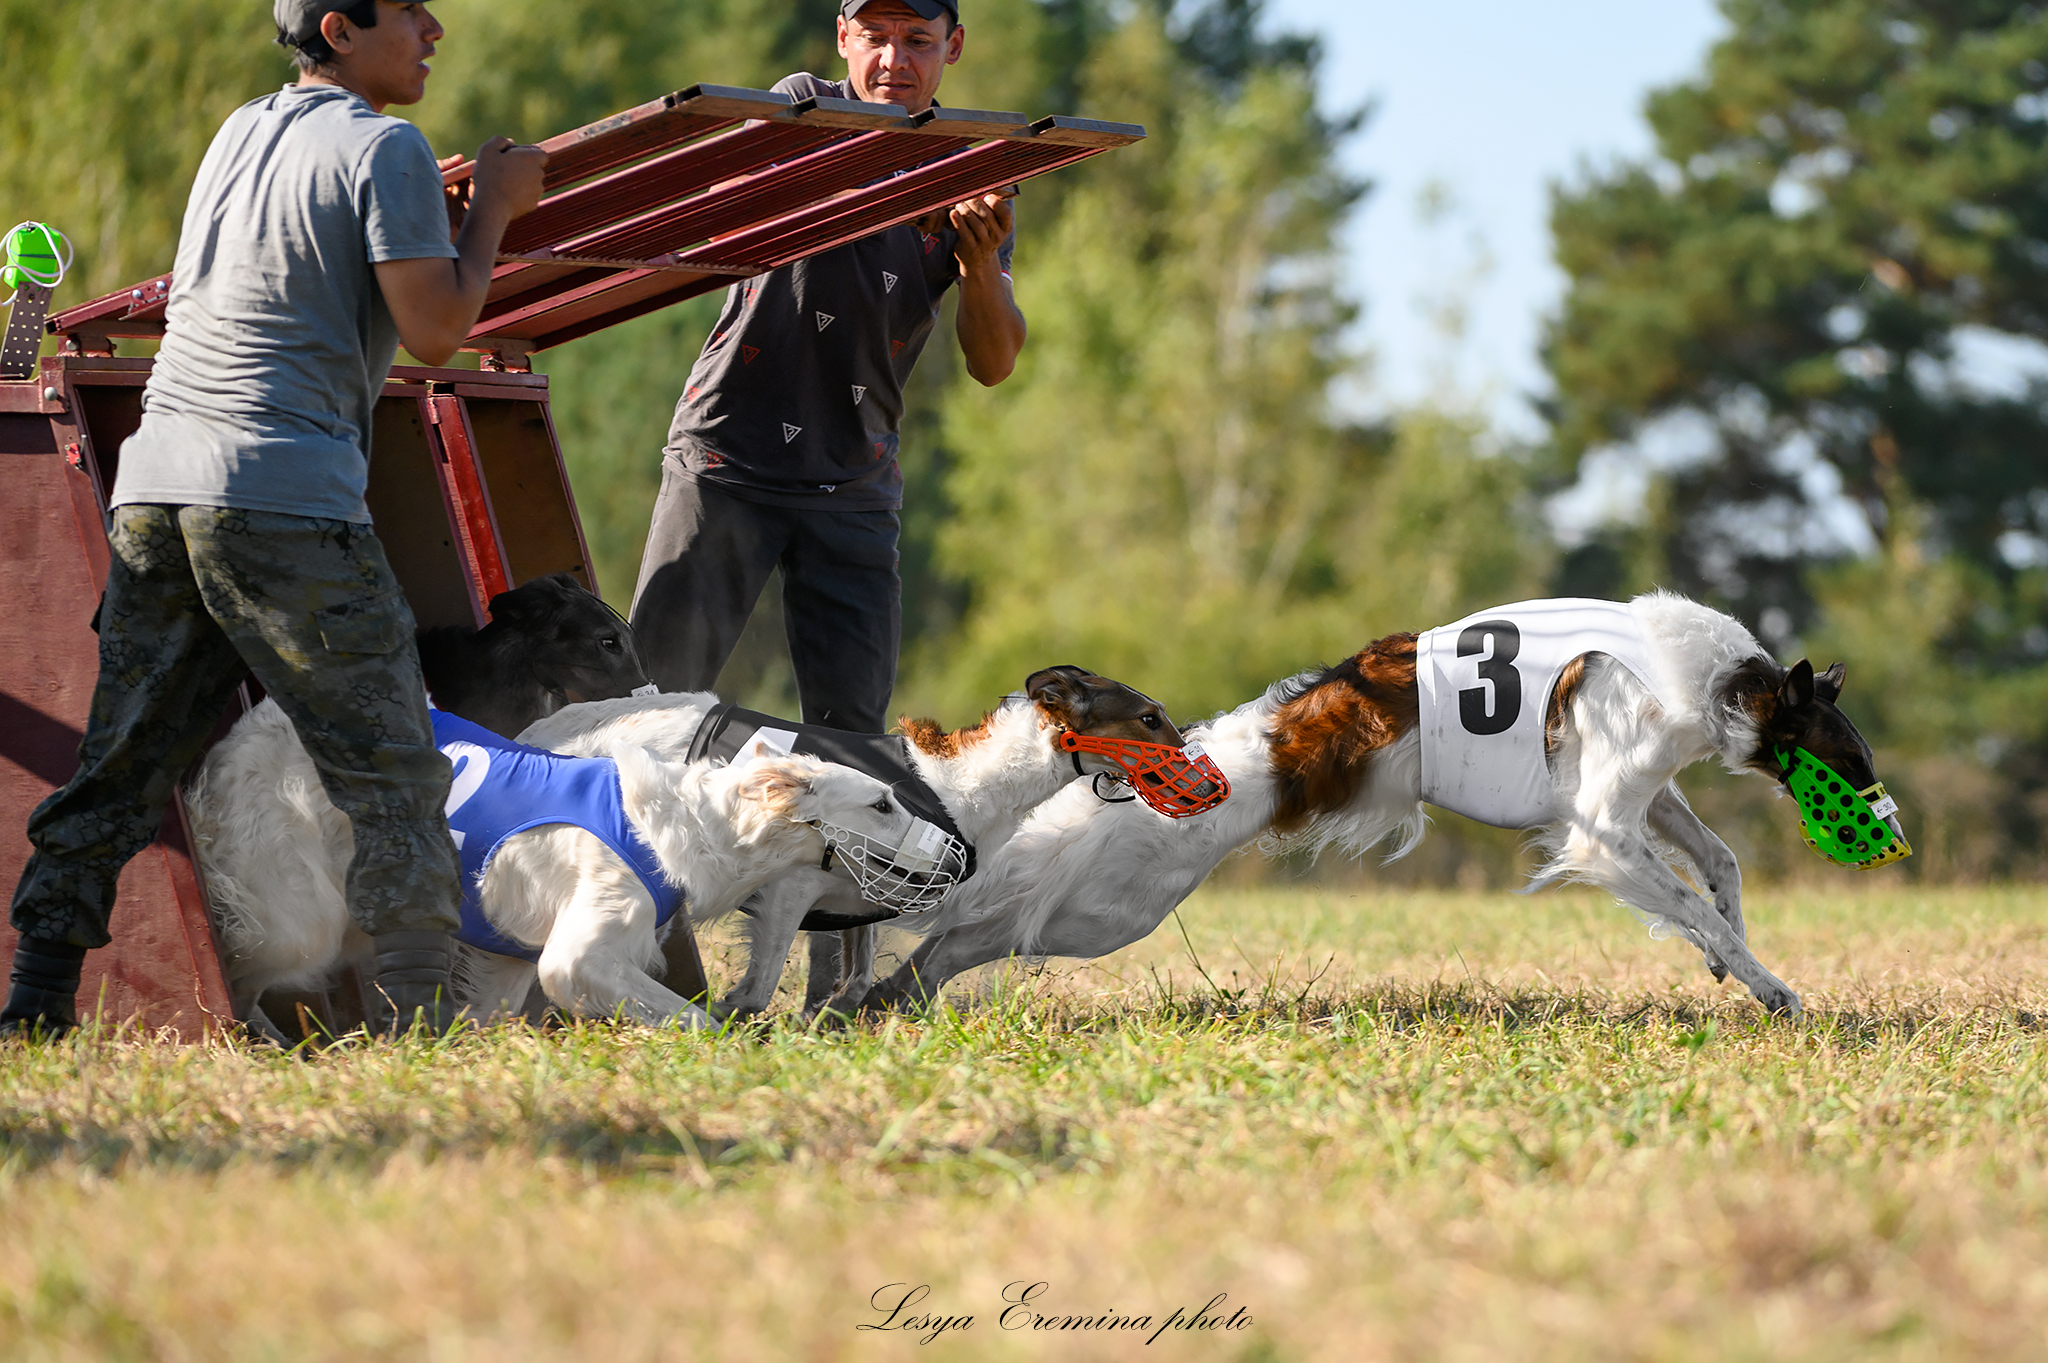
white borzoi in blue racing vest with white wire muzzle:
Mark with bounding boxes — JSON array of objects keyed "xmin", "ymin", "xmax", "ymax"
[{"xmin": 188, "ymin": 708, "xmax": 915, "ymax": 1027}]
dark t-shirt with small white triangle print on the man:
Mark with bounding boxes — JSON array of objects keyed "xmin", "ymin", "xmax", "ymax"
[{"xmin": 664, "ymin": 74, "xmax": 1014, "ymax": 512}]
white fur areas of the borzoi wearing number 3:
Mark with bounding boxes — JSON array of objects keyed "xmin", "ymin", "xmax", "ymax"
[{"xmin": 872, "ymin": 593, "xmax": 1800, "ymax": 1011}]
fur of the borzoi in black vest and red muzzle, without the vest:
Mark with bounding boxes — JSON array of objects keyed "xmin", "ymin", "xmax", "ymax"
[{"xmin": 520, "ymin": 667, "xmax": 1182, "ymax": 1013}]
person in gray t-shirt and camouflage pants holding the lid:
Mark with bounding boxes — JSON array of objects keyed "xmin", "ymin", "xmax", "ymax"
[{"xmin": 0, "ymin": 0, "xmax": 547, "ymax": 1036}]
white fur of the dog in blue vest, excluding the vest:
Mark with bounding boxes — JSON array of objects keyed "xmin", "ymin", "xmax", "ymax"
[{"xmin": 186, "ymin": 702, "xmax": 911, "ymax": 1027}]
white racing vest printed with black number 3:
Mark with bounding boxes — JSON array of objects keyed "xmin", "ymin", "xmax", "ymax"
[{"xmin": 1415, "ymin": 596, "xmax": 1659, "ymax": 829}]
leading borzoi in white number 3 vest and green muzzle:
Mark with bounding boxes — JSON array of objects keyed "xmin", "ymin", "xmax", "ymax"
[{"xmin": 868, "ymin": 593, "xmax": 1905, "ymax": 1011}]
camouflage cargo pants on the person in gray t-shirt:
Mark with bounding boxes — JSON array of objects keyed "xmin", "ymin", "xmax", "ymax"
[{"xmin": 10, "ymin": 505, "xmax": 461, "ymax": 948}]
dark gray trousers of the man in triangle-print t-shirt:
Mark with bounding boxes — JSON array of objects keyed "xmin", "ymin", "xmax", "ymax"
[{"xmin": 633, "ymin": 460, "xmax": 903, "ymax": 733}]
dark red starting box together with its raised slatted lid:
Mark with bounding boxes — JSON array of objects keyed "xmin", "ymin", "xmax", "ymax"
[{"xmin": 0, "ymin": 86, "xmax": 1145, "ymax": 1040}]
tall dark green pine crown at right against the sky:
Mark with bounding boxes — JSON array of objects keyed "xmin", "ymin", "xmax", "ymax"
[{"xmin": 1544, "ymin": 0, "xmax": 2048, "ymax": 626}]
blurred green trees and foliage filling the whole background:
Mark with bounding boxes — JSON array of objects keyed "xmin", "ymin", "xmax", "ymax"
[{"xmin": 0, "ymin": 0, "xmax": 2048, "ymax": 882}]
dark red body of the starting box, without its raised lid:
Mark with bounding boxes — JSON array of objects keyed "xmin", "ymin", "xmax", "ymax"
[{"xmin": 0, "ymin": 356, "xmax": 594, "ymax": 1040}]
